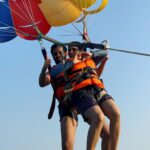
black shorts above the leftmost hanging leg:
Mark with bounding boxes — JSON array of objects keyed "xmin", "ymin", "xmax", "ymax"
[{"xmin": 58, "ymin": 103, "xmax": 78, "ymax": 121}]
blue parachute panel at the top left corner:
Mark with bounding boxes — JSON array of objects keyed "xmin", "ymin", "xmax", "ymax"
[{"xmin": 0, "ymin": 0, "xmax": 17, "ymax": 43}]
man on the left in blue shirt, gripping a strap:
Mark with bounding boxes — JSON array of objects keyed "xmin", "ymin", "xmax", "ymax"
[{"xmin": 39, "ymin": 44, "xmax": 77, "ymax": 150}]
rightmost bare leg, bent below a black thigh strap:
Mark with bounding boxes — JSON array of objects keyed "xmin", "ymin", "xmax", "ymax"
[{"xmin": 101, "ymin": 100, "xmax": 120, "ymax": 150}]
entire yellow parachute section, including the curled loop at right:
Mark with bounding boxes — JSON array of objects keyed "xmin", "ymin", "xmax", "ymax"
[{"xmin": 39, "ymin": 0, "xmax": 108, "ymax": 26}]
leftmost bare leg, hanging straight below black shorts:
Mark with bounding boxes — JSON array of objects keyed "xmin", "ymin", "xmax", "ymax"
[{"xmin": 61, "ymin": 116, "xmax": 77, "ymax": 150}]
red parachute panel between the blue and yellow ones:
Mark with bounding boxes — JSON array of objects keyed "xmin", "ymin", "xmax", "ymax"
[{"xmin": 9, "ymin": 0, "xmax": 50, "ymax": 40}]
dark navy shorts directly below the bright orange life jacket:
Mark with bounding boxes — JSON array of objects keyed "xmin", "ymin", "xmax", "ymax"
[{"xmin": 71, "ymin": 86, "xmax": 98, "ymax": 115}]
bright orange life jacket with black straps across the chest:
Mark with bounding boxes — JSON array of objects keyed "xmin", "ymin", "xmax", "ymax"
[{"xmin": 64, "ymin": 59, "xmax": 104, "ymax": 93}]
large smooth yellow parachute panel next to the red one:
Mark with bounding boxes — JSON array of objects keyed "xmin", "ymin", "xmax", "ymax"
[{"xmin": 39, "ymin": 0, "xmax": 82, "ymax": 26}]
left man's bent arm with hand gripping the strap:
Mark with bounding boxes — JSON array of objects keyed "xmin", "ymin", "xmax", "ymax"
[{"xmin": 39, "ymin": 59, "xmax": 51, "ymax": 87}]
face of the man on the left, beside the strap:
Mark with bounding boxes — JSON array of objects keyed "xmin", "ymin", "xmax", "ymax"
[{"xmin": 52, "ymin": 47, "xmax": 65, "ymax": 64}]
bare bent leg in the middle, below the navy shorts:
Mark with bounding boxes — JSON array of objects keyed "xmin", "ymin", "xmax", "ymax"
[{"xmin": 84, "ymin": 106, "xmax": 104, "ymax": 150}]
